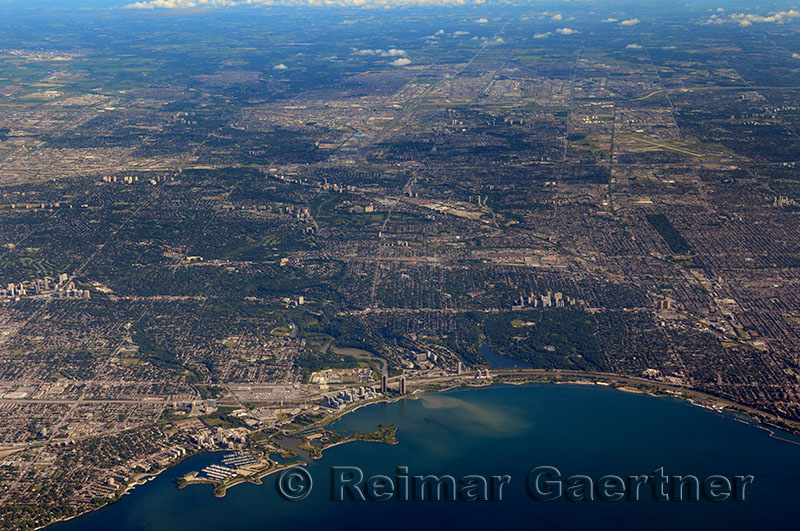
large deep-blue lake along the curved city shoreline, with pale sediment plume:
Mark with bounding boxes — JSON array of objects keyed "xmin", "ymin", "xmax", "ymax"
[{"xmin": 48, "ymin": 385, "xmax": 800, "ymax": 531}]
